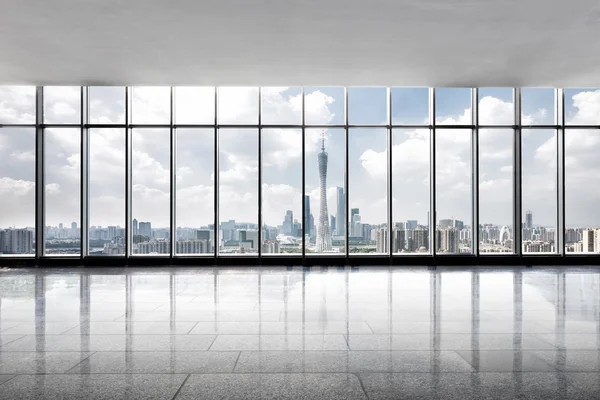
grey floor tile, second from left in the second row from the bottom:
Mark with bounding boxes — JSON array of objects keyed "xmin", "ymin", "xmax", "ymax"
[{"xmin": 68, "ymin": 351, "xmax": 239, "ymax": 374}]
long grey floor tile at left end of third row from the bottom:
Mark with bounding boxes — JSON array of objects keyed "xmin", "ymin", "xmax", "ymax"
[{"xmin": 0, "ymin": 335, "xmax": 215, "ymax": 351}]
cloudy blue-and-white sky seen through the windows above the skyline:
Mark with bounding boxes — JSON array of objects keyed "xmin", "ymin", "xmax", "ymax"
[{"xmin": 0, "ymin": 87, "xmax": 600, "ymax": 231}]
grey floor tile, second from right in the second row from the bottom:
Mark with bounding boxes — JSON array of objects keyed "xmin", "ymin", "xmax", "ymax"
[{"xmin": 456, "ymin": 350, "xmax": 557, "ymax": 372}]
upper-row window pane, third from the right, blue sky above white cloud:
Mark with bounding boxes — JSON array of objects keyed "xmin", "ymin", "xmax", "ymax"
[{"xmin": 478, "ymin": 88, "xmax": 515, "ymax": 125}]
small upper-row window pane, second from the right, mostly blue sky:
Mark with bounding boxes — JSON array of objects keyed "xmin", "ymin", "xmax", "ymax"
[{"xmin": 521, "ymin": 88, "xmax": 556, "ymax": 126}]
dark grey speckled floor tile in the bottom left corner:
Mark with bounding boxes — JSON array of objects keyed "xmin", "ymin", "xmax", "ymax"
[{"xmin": 0, "ymin": 374, "xmax": 186, "ymax": 400}]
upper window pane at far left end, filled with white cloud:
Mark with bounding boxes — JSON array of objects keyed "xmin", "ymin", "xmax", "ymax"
[{"xmin": 0, "ymin": 86, "xmax": 35, "ymax": 124}]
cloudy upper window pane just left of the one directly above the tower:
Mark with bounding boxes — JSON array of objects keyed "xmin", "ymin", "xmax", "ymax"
[{"xmin": 261, "ymin": 87, "xmax": 302, "ymax": 125}]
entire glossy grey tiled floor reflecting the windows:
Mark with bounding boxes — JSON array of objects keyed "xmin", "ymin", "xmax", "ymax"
[{"xmin": 0, "ymin": 267, "xmax": 600, "ymax": 400}]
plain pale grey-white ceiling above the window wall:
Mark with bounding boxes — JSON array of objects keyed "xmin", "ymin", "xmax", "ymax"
[{"xmin": 0, "ymin": 0, "xmax": 600, "ymax": 87}]
